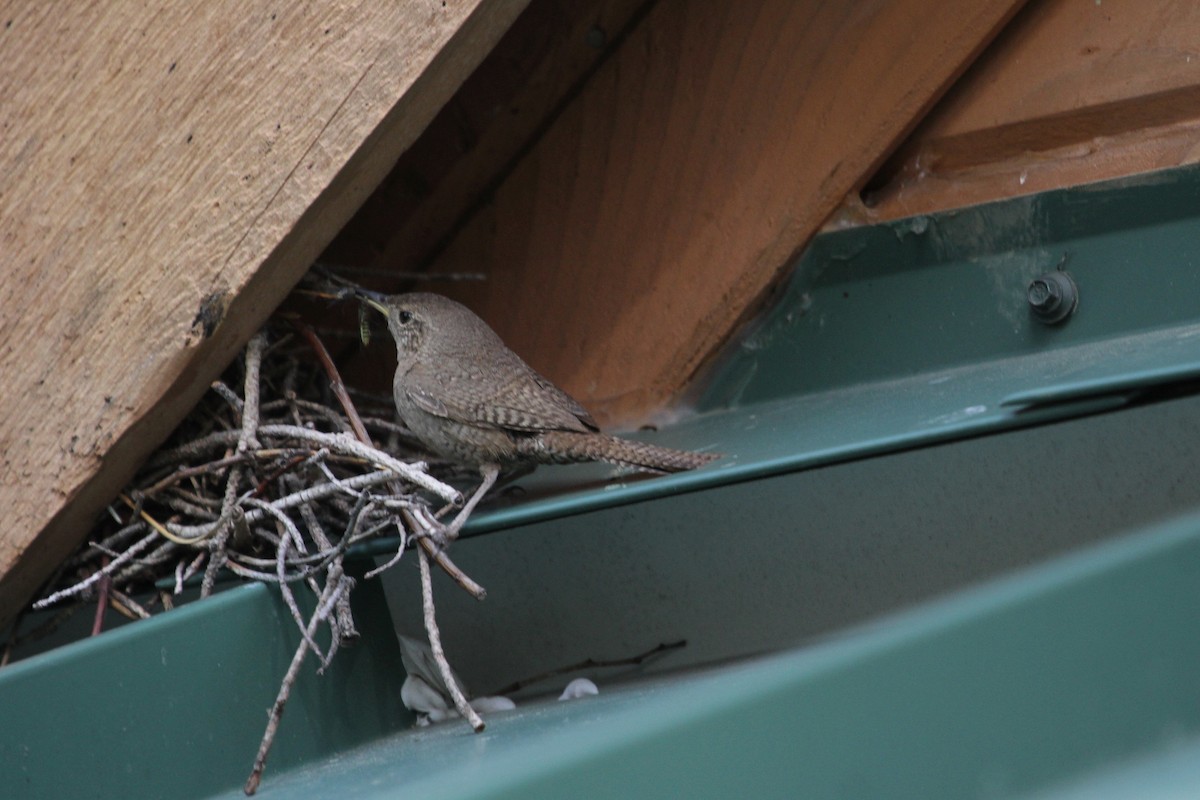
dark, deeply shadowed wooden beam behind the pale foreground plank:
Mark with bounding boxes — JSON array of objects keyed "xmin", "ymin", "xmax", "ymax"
[{"xmin": 322, "ymin": 0, "xmax": 653, "ymax": 272}]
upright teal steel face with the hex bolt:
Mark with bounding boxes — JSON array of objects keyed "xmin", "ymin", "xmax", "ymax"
[{"xmin": 700, "ymin": 167, "xmax": 1200, "ymax": 410}]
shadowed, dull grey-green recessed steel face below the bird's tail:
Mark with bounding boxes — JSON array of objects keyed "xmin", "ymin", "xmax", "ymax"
[{"xmin": 386, "ymin": 396, "xmax": 1200, "ymax": 710}]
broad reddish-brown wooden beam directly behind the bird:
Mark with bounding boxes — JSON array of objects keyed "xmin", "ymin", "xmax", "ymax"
[{"xmin": 410, "ymin": 0, "xmax": 1021, "ymax": 423}]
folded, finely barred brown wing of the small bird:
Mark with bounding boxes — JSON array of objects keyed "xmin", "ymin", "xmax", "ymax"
[{"xmin": 404, "ymin": 361, "xmax": 599, "ymax": 431}]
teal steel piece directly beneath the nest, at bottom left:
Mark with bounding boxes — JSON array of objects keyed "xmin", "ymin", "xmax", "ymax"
[{"xmin": 0, "ymin": 568, "xmax": 413, "ymax": 800}]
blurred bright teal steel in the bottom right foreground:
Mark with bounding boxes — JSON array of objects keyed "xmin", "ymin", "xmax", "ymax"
[{"xmin": 221, "ymin": 517, "xmax": 1200, "ymax": 800}]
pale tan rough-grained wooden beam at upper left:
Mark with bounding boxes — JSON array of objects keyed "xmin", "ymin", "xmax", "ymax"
[{"xmin": 0, "ymin": 0, "xmax": 524, "ymax": 622}]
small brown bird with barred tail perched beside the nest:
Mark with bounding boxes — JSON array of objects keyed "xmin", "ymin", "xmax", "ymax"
[{"xmin": 359, "ymin": 293, "xmax": 720, "ymax": 539}]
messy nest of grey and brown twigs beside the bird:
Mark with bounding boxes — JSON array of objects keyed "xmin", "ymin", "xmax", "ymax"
[{"xmin": 6, "ymin": 314, "xmax": 484, "ymax": 794}]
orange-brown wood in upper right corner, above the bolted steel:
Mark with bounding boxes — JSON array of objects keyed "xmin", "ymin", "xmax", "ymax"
[{"xmin": 851, "ymin": 0, "xmax": 1200, "ymax": 221}]
